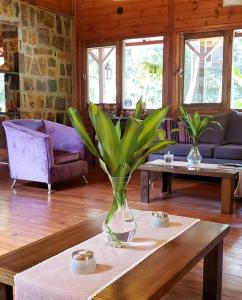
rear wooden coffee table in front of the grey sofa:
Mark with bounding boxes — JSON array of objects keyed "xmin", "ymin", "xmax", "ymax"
[{"xmin": 139, "ymin": 161, "xmax": 239, "ymax": 214}]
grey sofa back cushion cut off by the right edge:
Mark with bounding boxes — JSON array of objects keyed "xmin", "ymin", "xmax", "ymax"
[{"xmin": 225, "ymin": 110, "xmax": 242, "ymax": 145}]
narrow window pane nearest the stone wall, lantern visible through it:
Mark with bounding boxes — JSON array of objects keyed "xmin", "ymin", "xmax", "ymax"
[{"xmin": 87, "ymin": 46, "xmax": 116, "ymax": 103}]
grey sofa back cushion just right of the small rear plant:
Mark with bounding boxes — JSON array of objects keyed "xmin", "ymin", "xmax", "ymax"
[{"xmin": 199, "ymin": 113, "xmax": 230, "ymax": 145}]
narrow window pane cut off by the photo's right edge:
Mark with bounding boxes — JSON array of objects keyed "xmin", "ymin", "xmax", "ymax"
[{"xmin": 230, "ymin": 30, "xmax": 242, "ymax": 109}]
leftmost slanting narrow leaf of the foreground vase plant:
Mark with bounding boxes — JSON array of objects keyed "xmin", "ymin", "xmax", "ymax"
[{"xmin": 67, "ymin": 107, "xmax": 99, "ymax": 158}]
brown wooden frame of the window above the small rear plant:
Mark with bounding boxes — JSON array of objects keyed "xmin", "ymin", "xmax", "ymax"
[{"xmin": 177, "ymin": 30, "xmax": 233, "ymax": 111}]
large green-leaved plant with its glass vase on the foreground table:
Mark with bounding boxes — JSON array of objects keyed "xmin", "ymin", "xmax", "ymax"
[{"xmin": 68, "ymin": 100, "xmax": 174, "ymax": 247}]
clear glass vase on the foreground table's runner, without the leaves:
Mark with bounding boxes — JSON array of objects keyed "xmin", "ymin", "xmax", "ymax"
[{"xmin": 102, "ymin": 177, "xmax": 136, "ymax": 248}]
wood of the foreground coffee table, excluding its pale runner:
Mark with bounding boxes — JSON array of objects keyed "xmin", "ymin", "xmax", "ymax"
[{"xmin": 0, "ymin": 216, "xmax": 229, "ymax": 300}]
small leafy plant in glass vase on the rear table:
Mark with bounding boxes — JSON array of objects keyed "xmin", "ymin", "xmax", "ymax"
[{"xmin": 179, "ymin": 105, "xmax": 222, "ymax": 166}]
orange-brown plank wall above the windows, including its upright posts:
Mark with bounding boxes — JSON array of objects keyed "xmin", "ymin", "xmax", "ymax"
[{"xmin": 75, "ymin": 0, "xmax": 242, "ymax": 114}]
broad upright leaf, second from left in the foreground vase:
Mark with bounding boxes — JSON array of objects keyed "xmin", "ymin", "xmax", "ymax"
[{"xmin": 95, "ymin": 110, "xmax": 120, "ymax": 176}]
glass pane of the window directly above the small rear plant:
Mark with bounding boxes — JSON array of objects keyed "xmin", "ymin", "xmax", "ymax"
[{"xmin": 183, "ymin": 36, "xmax": 224, "ymax": 104}]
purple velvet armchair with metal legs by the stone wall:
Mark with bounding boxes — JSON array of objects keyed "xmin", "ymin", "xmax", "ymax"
[{"xmin": 3, "ymin": 120, "xmax": 88, "ymax": 193}]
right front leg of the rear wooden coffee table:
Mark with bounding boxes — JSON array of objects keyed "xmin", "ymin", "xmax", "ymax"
[{"xmin": 221, "ymin": 177, "xmax": 234, "ymax": 214}]
